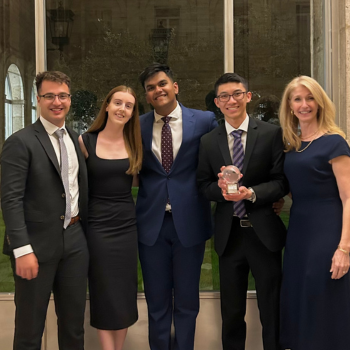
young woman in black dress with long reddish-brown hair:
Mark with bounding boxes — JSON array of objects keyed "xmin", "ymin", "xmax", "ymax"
[{"xmin": 79, "ymin": 86, "xmax": 142, "ymax": 350}]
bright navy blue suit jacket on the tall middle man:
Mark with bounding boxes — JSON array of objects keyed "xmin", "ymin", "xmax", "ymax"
[{"xmin": 136, "ymin": 105, "xmax": 217, "ymax": 247}]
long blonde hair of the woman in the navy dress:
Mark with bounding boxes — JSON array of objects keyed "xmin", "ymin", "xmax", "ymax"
[{"xmin": 279, "ymin": 75, "xmax": 345, "ymax": 152}]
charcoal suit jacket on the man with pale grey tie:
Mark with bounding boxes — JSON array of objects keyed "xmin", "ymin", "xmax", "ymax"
[{"xmin": 1, "ymin": 119, "xmax": 87, "ymax": 262}]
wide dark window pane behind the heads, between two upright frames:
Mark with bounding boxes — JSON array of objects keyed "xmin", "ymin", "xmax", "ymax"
[{"xmin": 46, "ymin": 0, "xmax": 224, "ymax": 290}]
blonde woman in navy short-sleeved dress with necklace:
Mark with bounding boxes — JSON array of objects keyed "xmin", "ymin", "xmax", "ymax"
[{"xmin": 280, "ymin": 76, "xmax": 350, "ymax": 350}]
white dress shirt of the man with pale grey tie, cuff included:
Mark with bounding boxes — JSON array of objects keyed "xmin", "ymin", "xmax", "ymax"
[{"xmin": 13, "ymin": 117, "xmax": 79, "ymax": 258}]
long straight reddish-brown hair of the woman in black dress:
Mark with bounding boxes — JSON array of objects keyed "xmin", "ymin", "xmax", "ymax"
[{"xmin": 87, "ymin": 85, "xmax": 142, "ymax": 175}]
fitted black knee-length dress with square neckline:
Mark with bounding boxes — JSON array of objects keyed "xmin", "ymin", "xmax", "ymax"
[{"xmin": 82, "ymin": 133, "xmax": 138, "ymax": 330}]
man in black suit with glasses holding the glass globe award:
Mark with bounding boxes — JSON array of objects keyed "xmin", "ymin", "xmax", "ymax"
[{"xmin": 197, "ymin": 73, "xmax": 288, "ymax": 350}]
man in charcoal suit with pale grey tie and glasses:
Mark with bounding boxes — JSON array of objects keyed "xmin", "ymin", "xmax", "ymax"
[{"xmin": 1, "ymin": 71, "xmax": 89, "ymax": 350}]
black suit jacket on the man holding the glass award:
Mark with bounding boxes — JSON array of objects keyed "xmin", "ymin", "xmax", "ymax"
[{"xmin": 197, "ymin": 118, "xmax": 288, "ymax": 255}]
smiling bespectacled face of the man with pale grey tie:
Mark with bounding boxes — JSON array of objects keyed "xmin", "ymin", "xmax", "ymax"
[{"xmin": 37, "ymin": 80, "xmax": 71, "ymax": 128}]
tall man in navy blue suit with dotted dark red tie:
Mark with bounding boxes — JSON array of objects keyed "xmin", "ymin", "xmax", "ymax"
[{"xmin": 136, "ymin": 64, "xmax": 217, "ymax": 350}]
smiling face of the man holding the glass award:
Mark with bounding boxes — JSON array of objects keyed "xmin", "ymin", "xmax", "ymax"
[{"xmin": 214, "ymin": 82, "xmax": 252, "ymax": 128}]
